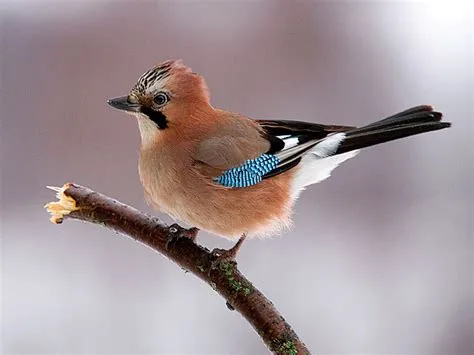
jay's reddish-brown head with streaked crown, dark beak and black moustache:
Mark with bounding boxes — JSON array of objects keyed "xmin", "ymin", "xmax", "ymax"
[{"xmin": 107, "ymin": 60, "xmax": 210, "ymax": 141}]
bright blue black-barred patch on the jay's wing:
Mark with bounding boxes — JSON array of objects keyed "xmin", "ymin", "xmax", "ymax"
[{"xmin": 215, "ymin": 154, "xmax": 280, "ymax": 187}]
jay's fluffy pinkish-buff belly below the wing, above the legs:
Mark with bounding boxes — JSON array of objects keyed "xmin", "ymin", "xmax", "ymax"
[{"xmin": 147, "ymin": 174, "xmax": 292, "ymax": 238}]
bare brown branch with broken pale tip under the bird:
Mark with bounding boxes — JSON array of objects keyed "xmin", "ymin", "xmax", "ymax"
[{"xmin": 45, "ymin": 183, "xmax": 309, "ymax": 355}]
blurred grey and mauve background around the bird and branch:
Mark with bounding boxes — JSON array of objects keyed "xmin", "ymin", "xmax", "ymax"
[{"xmin": 0, "ymin": 0, "xmax": 474, "ymax": 355}]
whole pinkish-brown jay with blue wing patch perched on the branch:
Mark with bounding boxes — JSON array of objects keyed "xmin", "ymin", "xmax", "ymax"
[{"xmin": 108, "ymin": 60, "xmax": 451, "ymax": 260}]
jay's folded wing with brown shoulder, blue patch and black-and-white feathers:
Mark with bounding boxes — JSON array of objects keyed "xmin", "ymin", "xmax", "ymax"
[{"xmin": 194, "ymin": 120, "xmax": 352, "ymax": 187}]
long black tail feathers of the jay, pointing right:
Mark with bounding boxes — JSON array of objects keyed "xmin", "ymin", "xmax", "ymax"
[{"xmin": 336, "ymin": 105, "xmax": 451, "ymax": 154}]
